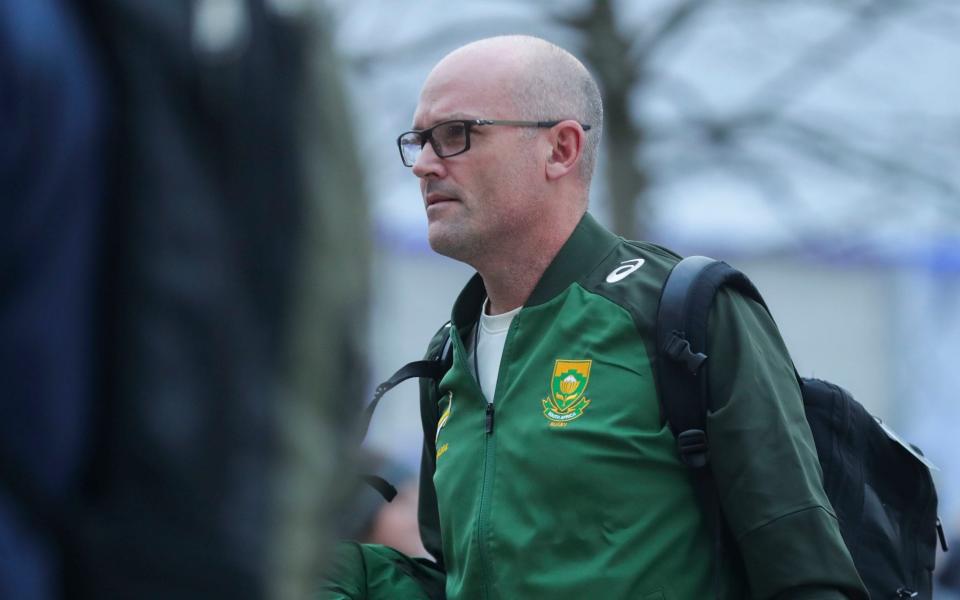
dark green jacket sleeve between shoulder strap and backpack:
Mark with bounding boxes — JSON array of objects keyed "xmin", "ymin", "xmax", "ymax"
[{"xmin": 707, "ymin": 290, "xmax": 868, "ymax": 600}]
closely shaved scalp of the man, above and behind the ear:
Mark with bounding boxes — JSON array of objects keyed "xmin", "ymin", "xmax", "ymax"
[{"xmin": 435, "ymin": 35, "xmax": 603, "ymax": 184}]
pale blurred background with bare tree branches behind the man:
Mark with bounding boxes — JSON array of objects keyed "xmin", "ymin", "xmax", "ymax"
[{"xmin": 328, "ymin": 0, "xmax": 960, "ymax": 592}]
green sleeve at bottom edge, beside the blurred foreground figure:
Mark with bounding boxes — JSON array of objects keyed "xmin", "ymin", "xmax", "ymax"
[{"xmin": 315, "ymin": 542, "xmax": 443, "ymax": 600}]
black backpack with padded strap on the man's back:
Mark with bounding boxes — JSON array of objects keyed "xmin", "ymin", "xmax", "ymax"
[{"xmin": 657, "ymin": 256, "xmax": 947, "ymax": 599}]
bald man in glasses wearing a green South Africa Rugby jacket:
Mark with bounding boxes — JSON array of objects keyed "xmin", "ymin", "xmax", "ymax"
[{"xmin": 325, "ymin": 36, "xmax": 866, "ymax": 599}]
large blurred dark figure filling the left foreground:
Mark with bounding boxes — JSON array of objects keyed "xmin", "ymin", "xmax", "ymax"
[{"xmin": 0, "ymin": 0, "xmax": 368, "ymax": 598}]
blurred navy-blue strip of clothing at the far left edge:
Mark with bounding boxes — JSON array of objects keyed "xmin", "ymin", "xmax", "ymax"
[{"xmin": 0, "ymin": 0, "xmax": 108, "ymax": 600}]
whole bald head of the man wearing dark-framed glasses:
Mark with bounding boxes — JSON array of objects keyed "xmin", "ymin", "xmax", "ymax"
[{"xmin": 404, "ymin": 36, "xmax": 603, "ymax": 268}]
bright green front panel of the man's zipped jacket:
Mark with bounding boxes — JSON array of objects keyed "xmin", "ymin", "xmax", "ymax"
[{"xmin": 434, "ymin": 282, "xmax": 711, "ymax": 599}]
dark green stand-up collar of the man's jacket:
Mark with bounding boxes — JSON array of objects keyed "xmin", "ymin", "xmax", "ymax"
[{"xmin": 452, "ymin": 213, "xmax": 620, "ymax": 328}]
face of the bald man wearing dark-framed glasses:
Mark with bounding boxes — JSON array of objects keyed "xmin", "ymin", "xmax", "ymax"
[{"xmin": 413, "ymin": 56, "xmax": 543, "ymax": 266}]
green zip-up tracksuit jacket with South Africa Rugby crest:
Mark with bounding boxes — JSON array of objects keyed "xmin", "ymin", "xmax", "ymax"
[{"xmin": 323, "ymin": 215, "xmax": 866, "ymax": 600}]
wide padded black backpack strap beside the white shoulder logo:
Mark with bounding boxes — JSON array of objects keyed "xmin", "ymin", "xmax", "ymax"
[{"xmin": 657, "ymin": 256, "xmax": 766, "ymax": 468}]
